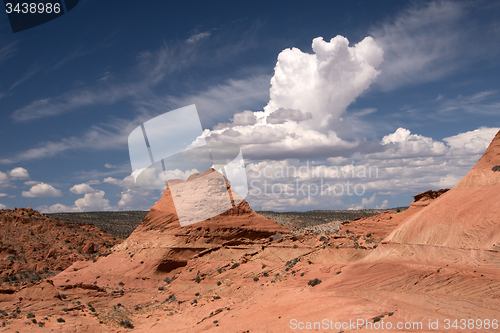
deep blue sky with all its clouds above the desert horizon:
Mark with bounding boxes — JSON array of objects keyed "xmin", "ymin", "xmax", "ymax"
[{"xmin": 0, "ymin": 0, "xmax": 500, "ymax": 213}]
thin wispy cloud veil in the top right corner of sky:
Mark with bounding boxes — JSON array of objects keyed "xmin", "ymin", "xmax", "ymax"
[{"xmin": 370, "ymin": 0, "xmax": 500, "ymax": 90}]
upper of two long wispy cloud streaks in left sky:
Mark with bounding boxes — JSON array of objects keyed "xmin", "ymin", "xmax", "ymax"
[{"xmin": 11, "ymin": 25, "xmax": 258, "ymax": 122}]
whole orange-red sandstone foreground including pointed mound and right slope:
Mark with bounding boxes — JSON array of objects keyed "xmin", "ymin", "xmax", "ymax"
[{"xmin": 0, "ymin": 132, "xmax": 500, "ymax": 333}]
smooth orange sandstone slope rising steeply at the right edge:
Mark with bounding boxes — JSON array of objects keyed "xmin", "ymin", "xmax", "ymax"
[{"xmin": 385, "ymin": 132, "xmax": 500, "ymax": 251}]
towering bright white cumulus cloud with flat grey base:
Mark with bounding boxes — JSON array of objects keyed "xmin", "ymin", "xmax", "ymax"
[{"xmin": 198, "ymin": 36, "xmax": 383, "ymax": 159}]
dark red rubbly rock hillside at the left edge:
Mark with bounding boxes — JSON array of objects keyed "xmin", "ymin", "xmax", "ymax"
[{"xmin": 0, "ymin": 207, "xmax": 120, "ymax": 286}]
